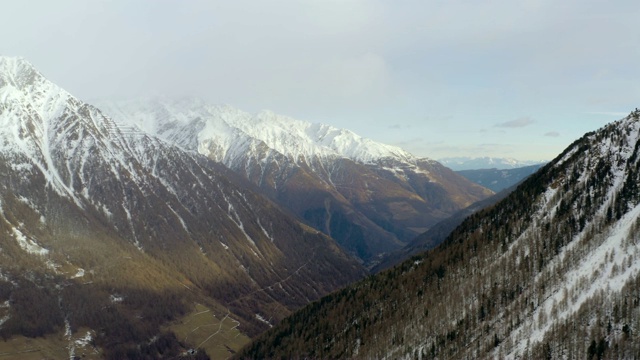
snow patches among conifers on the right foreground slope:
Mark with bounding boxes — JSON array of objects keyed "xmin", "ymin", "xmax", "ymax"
[{"xmin": 484, "ymin": 115, "xmax": 640, "ymax": 358}]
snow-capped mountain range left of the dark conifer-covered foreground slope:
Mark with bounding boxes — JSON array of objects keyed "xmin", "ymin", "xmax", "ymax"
[{"xmin": 0, "ymin": 57, "xmax": 500, "ymax": 358}]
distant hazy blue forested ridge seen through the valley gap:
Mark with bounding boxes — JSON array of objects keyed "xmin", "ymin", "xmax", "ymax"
[{"xmin": 457, "ymin": 164, "xmax": 544, "ymax": 193}]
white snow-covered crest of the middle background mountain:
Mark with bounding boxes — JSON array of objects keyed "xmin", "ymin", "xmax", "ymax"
[{"xmin": 98, "ymin": 99, "xmax": 418, "ymax": 167}]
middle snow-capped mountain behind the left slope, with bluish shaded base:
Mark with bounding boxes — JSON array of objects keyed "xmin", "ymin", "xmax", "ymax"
[{"xmin": 98, "ymin": 99, "xmax": 491, "ymax": 262}]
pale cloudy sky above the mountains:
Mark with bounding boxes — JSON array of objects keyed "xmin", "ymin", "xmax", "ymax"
[{"xmin": 0, "ymin": 0, "xmax": 640, "ymax": 160}]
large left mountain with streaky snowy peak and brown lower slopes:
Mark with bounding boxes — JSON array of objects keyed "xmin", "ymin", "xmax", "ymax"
[{"xmin": 0, "ymin": 57, "xmax": 364, "ymax": 358}]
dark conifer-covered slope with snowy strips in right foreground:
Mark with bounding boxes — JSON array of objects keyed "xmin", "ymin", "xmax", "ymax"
[{"xmin": 239, "ymin": 110, "xmax": 640, "ymax": 359}]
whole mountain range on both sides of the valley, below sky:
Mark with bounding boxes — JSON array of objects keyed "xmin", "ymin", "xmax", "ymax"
[{"xmin": 6, "ymin": 57, "xmax": 640, "ymax": 359}]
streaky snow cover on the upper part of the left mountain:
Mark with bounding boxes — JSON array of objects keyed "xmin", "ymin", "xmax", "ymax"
[{"xmin": 0, "ymin": 57, "xmax": 264, "ymax": 254}]
